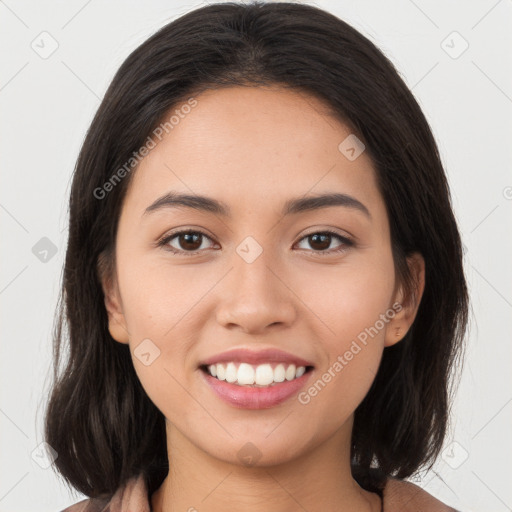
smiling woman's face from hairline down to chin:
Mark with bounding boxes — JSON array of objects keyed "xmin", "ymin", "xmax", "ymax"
[{"xmin": 105, "ymin": 87, "xmax": 423, "ymax": 464}]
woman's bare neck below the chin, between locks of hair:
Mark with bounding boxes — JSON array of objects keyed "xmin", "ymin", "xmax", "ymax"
[{"xmin": 151, "ymin": 421, "xmax": 380, "ymax": 512}]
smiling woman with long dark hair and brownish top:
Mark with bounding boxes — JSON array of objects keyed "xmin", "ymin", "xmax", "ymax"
[{"xmin": 45, "ymin": 3, "xmax": 468, "ymax": 512}]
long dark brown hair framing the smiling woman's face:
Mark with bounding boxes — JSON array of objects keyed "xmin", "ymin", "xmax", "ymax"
[{"xmin": 45, "ymin": 2, "xmax": 468, "ymax": 497}]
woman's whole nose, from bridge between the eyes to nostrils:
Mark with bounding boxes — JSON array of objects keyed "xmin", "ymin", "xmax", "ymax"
[{"xmin": 217, "ymin": 236, "xmax": 295, "ymax": 331}]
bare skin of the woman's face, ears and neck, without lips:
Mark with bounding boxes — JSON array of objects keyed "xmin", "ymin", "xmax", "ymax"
[{"xmin": 103, "ymin": 87, "xmax": 424, "ymax": 512}]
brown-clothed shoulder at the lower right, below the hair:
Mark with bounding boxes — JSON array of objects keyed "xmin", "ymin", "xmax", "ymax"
[{"xmin": 383, "ymin": 478, "xmax": 457, "ymax": 512}]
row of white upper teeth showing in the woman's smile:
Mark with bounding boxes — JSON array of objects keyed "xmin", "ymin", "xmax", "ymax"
[{"xmin": 208, "ymin": 362, "xmax": 306, "ymax": 386}]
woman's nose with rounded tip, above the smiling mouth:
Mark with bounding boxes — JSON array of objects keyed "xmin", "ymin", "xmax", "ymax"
[{"xmin": 216, "ymin": 242, "xmax": 298, "ymax": 334}]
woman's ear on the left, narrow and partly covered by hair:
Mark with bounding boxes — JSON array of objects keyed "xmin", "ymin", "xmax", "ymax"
[{"xmin": 98, "ymin": 249, "xmax": 129, "ymax": 344}]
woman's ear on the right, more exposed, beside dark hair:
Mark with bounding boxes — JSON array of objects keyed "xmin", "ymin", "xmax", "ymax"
[{"xmin": 384, "ymin": 253, "xmax": 425, "ymax": 347}]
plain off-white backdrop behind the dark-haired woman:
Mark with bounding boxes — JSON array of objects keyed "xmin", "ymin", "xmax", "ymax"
[{"xmin": 0, "ymin": 0, "xmax": 512, "ymax": 512}]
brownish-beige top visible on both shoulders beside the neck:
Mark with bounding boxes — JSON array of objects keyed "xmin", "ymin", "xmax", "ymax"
[{"xmin": 61, "ymin": 474, "xmax": 457, "ymax": 512}]
